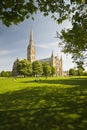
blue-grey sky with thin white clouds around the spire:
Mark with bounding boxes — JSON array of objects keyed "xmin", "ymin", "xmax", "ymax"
[{"xmin": 0, "ymin": 13, "xmax": 75, "ymax": 72}]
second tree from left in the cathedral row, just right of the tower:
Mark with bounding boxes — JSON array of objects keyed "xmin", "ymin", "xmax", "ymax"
[{"xmin": 32, "ymin": 61, "xmax": 43, "ymax": 77}]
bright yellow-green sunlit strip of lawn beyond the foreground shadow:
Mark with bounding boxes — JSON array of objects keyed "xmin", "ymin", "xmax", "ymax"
[{"xmin": 0, "ymin": 77, "xmax": 84, "ymax": 93}]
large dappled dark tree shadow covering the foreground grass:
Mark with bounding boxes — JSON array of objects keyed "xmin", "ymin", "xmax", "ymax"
[{"xmin": 0, "ymin": 81, "xmax": 87, "ymax": 130}]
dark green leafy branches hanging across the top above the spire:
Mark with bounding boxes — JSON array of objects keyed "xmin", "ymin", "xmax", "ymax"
[{"xmin": 0, "ymin": 0, "xmax": 87, "ymax": 26}]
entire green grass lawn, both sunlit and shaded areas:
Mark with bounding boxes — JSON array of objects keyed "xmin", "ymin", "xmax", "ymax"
[{"xmin": 0, "ymin": 77, "xmax": 87, "ymax": 130}]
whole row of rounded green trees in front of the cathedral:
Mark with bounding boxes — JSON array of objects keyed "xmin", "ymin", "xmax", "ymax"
[{"xmin": 12, "ymin": 59, "xmax": 56, "ymax": 77}]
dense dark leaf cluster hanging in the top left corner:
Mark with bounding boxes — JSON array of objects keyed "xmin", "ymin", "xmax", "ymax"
[{"xmin": 0, "ymin": 0, "xmax": 37, "ymax": 26}]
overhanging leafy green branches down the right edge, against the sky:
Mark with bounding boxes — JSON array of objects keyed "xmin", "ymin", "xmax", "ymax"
[{"xmin": 57, "ymin": 1, "xmax": 87, "ymax": 61}]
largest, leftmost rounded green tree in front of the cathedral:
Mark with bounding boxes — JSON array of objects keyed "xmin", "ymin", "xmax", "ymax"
[{"xmin": 17, "ymin": 59, "xmax": 32, "ymax": 77}]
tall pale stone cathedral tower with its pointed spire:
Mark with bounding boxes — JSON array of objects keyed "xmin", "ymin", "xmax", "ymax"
[{"xmin": 27, "ymin": 29, "xmax": 36, "ymax": 63}]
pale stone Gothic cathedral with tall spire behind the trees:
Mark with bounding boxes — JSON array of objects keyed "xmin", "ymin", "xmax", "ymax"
[{"xmin": 13, "ymin": 29, "xmax": 63, "ymax": 76}]
